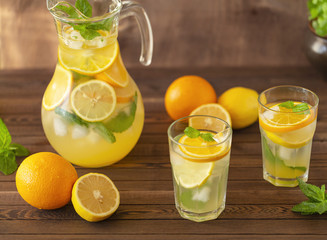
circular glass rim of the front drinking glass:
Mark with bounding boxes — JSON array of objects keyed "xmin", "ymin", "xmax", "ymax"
[{"xmin": 167, "ymin": 115, "xmax": 233, "ymax": 148}]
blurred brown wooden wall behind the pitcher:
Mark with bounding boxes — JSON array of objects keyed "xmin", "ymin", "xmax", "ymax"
[{"xmin": 0, "ymin": 0, "xmax": 309, "ymax": 69}]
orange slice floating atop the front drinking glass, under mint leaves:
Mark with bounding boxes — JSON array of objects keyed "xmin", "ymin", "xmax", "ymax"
[{"xmin": 178, "ymin": 131, "xmax": 229, "ymax": 162}]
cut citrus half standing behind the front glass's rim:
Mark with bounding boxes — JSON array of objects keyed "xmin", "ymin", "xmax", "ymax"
[{"xmin": 189, "ymin": 103, "xmax": 232, "ymax": 131}]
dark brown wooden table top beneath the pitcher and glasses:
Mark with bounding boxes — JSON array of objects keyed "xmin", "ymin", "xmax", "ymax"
[{"xmin": 0, "ymin": 68, "xmax": 327, "ymax": 240}]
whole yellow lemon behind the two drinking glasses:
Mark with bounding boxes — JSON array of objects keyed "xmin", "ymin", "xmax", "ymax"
[{"xmin": 218, "ymin": 87, "xmax": 258, "ymax": 129}]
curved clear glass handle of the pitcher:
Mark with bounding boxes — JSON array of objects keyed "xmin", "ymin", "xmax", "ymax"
[{"xmin": 120, "ymin": 1, "xmax": 153, "ymax": 66}]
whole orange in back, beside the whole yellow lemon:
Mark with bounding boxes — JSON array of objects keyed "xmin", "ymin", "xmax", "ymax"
[{"xmin": 165, "ymin": 75, "xmax": 217, "ymax": 120}]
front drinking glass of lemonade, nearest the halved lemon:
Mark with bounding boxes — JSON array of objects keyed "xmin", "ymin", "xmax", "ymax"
[{"xmin": 168, "ymin": 115, "xmax": 232, "ymax": 222}]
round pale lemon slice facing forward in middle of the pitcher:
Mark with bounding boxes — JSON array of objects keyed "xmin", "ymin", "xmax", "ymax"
[{"xmin": 70, "ymin": 80, "xmax": 116, "ymax": 122}]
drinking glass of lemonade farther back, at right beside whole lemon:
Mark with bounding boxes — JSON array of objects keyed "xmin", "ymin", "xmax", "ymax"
[{"xmin": 258, "ymin": 86, "xmax": 319, "ymax": 187}]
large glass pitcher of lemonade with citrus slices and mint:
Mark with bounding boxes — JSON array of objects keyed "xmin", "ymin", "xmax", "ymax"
[{"xmin": 41, "ymin": 0, "xmax": 153, "ymax": 167}]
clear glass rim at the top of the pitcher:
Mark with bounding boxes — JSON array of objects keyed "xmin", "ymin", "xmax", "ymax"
[{"xmin": 47, "ymin": 0, "xmax": 123, "ymax": 24}]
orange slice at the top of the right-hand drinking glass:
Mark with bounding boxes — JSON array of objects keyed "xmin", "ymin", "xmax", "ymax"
[{"xmin": 259, "ymin": 102, "xmax": 316, "ymax": 133}]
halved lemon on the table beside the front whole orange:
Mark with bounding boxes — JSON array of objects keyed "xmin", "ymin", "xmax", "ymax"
[{"xmin": 72, "ymin": 173, "xmax": 120, "ymax": 222}]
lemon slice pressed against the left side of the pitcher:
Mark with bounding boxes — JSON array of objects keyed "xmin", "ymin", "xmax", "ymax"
[{"xmin": 42, "ymin": 64, "xmax": 73, "ymax": 111}]
